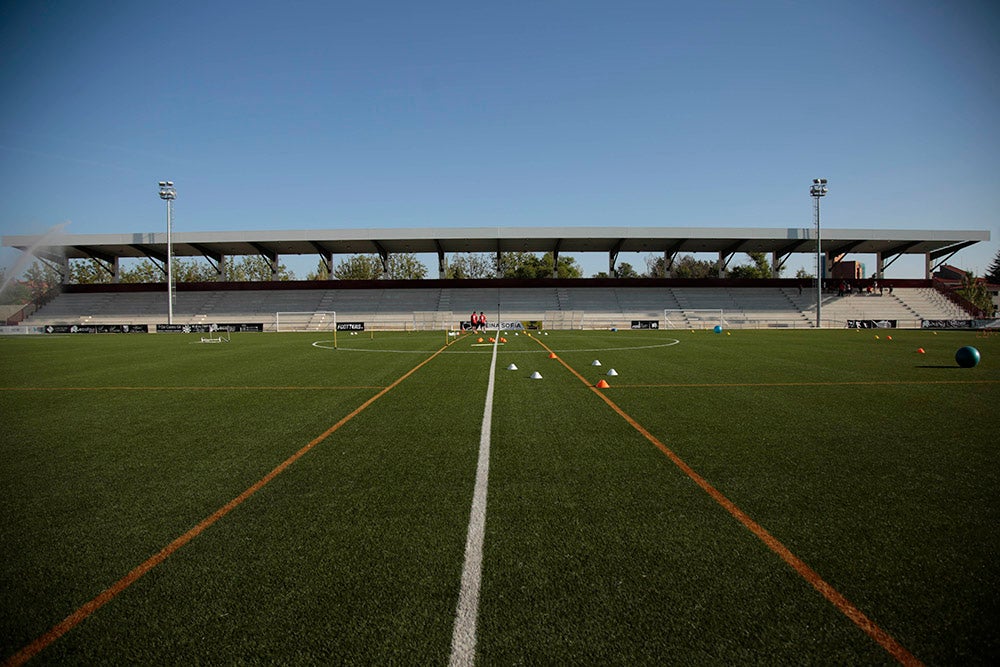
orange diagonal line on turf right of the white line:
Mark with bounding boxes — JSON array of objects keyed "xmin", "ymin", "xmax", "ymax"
[{"xmin": 535, "ymin": 338, "xmax": 923, "ymax": 665}]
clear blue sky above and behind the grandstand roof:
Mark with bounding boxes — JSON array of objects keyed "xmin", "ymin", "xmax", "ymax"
[{"xmin": 0, "ymin": 0, "xmax": 1000, "ymax": 277}]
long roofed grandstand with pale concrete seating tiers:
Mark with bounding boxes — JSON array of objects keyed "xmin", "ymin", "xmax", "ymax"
[{"xmin": 3, "ymin": 227, "xmax": 990, "ymax": 331}]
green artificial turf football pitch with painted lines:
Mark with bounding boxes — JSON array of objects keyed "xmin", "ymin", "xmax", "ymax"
[{"xmin": 0, "ymin": 330, "xmax": 1000, "ymax": 665}]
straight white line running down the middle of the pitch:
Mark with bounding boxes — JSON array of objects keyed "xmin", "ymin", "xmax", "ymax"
[{"xmin": 448, "ymin": 331, "xmax": 500, "ymax": 667}]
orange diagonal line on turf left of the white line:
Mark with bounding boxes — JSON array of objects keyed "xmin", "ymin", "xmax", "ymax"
[{"xmin": 4, "ymin": 345, "xmax": 447, "ymax": 667}]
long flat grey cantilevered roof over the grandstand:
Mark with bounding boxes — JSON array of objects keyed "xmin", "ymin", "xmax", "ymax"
[{"xmin": 3, "ymin": 227, "xmax": 990, "ymax": 261}]
